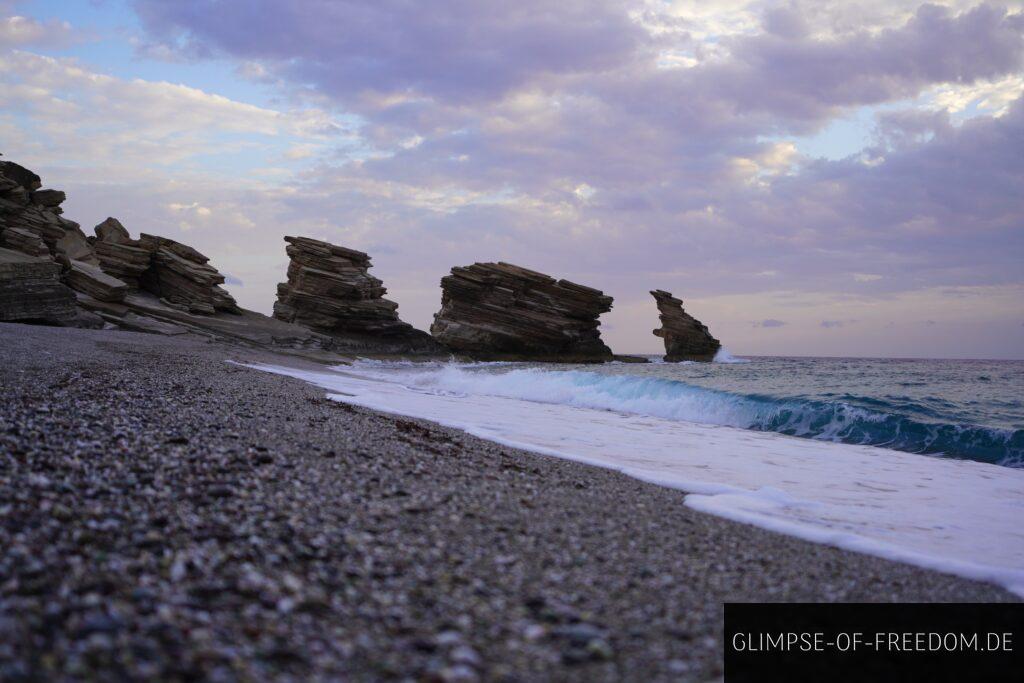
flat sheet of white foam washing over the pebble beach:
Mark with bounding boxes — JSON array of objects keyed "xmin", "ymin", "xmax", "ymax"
[{"xmin": 251, "ymin": 365, "xmax": 1024, "ymax": 595}]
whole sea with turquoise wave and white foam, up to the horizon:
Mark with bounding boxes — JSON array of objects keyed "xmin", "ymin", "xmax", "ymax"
[{"xmin": 247, "ymin": 350, "xmax": 1024, "ymax": 595}]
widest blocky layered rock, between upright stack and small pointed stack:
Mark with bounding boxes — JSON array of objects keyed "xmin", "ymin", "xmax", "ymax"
[{"xmin": 430, "ymin": 263, "xmax": 611, "ymax": 362}]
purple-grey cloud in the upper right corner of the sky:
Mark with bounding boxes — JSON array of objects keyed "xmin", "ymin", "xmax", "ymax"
[{"xmin": 709, "ymin": 4, "xmax": 1024, "ymax": 118}]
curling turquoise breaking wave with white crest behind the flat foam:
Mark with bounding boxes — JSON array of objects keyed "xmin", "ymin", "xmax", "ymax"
[{"xmin": 355, "ymin": 365, "xmax": 1024, "ymax": 467}]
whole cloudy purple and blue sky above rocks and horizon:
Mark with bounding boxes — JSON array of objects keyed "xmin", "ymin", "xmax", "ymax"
[{"xmin": 0, "ymin": 0, "xmax": 1024, "ymax": 358}]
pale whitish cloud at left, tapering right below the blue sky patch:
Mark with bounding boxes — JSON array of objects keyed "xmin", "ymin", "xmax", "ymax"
[{"xmin": 0, "ymin": 50, "xmax": 344, "ymax": 175}]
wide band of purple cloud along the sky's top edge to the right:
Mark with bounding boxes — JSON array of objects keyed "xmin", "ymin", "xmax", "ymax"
[{"xmin": 135, "ymin": 0, "xmax": 1024, "ymax": 139}]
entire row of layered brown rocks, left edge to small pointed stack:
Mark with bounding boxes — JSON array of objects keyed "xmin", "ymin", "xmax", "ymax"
[{"xmin": 0, "ymin": 161, "xmax": 720, "ymax": 362}]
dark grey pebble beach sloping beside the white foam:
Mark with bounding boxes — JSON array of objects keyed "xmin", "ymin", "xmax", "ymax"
[{"xmin": 0, "ymin": 325, "xmax": 1014, "ymax": 681}]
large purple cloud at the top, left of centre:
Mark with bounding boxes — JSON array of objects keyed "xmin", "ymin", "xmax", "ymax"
[{"xmin": 135, "ymin": 0, "xmax": 644, "ymax": 100}]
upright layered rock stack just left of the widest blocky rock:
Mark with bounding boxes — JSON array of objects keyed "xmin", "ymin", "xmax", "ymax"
[{"xmin": 273, "ymin": 237, "xmax": 438, "ymax": 351}]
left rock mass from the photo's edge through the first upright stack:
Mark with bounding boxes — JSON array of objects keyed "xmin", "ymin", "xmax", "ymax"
[{"xmin": 0, "ymin": 154, "xmax": 477, "ymax": 362}]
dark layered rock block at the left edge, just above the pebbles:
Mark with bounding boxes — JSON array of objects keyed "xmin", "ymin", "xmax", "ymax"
[{"xmin": 0, "ymin": 248, "xmax": 77, "ymax": 325}]
